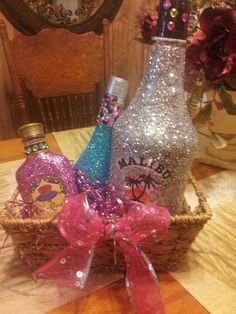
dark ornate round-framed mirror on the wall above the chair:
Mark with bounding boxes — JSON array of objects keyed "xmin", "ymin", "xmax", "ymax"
[{"xmin": 0, "ymin": 0, "xmax": 122, "ymax": 35}]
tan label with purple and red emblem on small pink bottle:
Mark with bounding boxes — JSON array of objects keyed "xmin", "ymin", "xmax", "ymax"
[{"xmin": 31, "ymin": 176, "xmax": 66, "ymax": 218}]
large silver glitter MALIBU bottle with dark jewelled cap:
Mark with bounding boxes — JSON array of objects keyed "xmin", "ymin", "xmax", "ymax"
[{"xmin": 110, "ymin": 0, "xmax": 196, "ymax": 215}]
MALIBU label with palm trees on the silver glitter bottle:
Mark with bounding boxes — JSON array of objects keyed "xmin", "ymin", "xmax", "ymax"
[{"xmin": 118, "ymin": 156, "xmax": 171, "ymax": 204}]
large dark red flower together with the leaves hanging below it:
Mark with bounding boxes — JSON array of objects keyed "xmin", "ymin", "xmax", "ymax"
[{"xmin": 186, "ymin": 7, "xmax": 236, "ymax": 126}]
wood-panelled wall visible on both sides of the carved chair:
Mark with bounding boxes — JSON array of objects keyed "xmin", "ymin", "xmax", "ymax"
[{"xmin": 0, "ymin": 0, "xmax": 158, "ymax": 140}]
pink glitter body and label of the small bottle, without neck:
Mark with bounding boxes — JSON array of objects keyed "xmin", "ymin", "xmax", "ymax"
[{"xmin": 16, "ymin": 151, "xmax": 77, "ymax": 218}]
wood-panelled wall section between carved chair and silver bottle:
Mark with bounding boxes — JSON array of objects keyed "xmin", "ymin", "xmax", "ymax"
[{"xmin": 111, "ymin": 0, "xmax": 158, "ymax": 102}]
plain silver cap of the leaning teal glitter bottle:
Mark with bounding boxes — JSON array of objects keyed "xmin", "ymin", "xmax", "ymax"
[{"xmin": 106, "ymin": 75, "xmax": 129, "ymax": 105}]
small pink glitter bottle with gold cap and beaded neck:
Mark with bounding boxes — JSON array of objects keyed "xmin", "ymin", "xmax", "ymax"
[{"xmin": 16, "ymin": 123, "xmax": 77, "ymax": 218}]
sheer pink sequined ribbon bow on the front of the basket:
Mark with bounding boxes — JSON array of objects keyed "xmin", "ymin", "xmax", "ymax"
[{"xmin": 33, "ymin": 192, "xmax": 170, "ymax": 314}]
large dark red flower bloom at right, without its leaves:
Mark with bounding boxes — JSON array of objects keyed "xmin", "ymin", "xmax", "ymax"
[{"xmin": 186, "ymin": 8, "xmax": 236, "ymax": 83}]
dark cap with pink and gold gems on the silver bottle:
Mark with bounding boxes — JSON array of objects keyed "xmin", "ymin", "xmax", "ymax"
[{"xmin": 157, "ymin": 0, "xmax": 191, "ymax": 39}]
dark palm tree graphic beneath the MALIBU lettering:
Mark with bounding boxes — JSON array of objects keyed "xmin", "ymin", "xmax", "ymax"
[{"xmin": 125, "ymin": 174, "xmax": 158, "ymax": 203}]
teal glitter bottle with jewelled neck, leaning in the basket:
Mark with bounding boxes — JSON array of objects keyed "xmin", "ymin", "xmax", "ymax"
[{"xmin": 75, "ymin": 76, "xmax": 128, "ymax": 184}]
